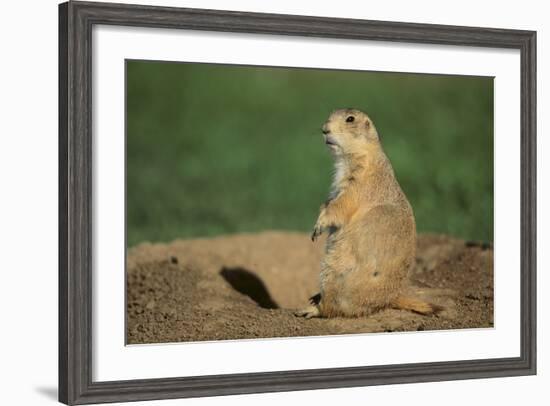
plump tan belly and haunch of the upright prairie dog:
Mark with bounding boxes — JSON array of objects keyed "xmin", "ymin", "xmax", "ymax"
[{"xmin": 321, "ymin": 205, "xmax": 415, "ymax": 316}]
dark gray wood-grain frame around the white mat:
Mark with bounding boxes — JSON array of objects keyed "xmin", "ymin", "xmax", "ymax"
[{"xmin": 59, "ymin": 2, "xmax": 536, "ymax": 404}]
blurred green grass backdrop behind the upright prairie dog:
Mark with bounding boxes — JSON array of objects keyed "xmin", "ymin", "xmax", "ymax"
[{"xmin": 126, "ymin": 61, "xmax": 493, "ymax": 246}]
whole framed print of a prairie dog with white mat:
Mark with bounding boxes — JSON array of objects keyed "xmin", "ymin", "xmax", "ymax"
[{"xmin": 59, "ymin": 2, "xmax": 536, "ymax": 404}]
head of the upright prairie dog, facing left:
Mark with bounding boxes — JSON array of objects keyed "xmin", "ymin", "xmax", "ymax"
[{"xmin": 322, "ymin": 109, "xmax": 379, "ymax": 156}]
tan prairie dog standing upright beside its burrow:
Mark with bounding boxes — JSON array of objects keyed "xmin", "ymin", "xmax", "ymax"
[{"xmin": 296, "ymin": 109, "xmax": 439, "ymax": 318}]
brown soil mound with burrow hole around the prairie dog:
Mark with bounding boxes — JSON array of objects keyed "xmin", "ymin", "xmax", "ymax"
[{"xmin": 127, "ymin": 231, "xmax": 493, "ymax": 344}]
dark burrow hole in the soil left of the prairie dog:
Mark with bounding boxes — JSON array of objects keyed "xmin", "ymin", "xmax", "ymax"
[{"xmin": 220, "ymin": 267, "xmax": 279, "ymax": 309}]
